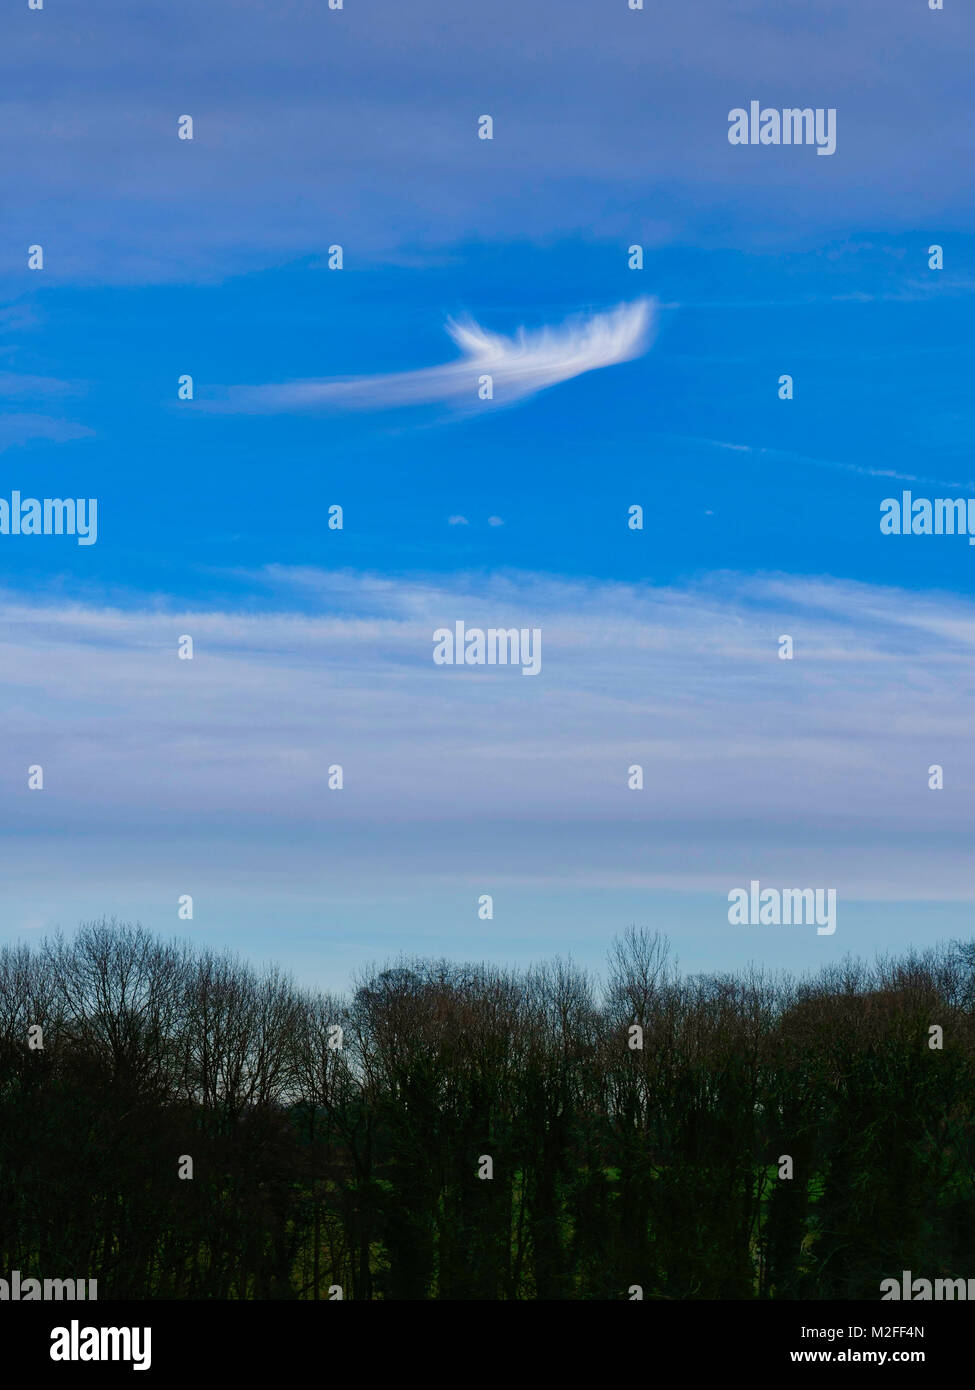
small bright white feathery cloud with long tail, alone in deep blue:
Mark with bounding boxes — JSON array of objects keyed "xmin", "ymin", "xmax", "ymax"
[{"xmin": 216, "ymin": 299, "xmax": 655, "ymax": 413}]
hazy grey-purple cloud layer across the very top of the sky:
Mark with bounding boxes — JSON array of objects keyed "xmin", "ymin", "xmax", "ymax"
[{"xmin": 4, "ymin": 0, "xmax": 975, "ymax": 284}]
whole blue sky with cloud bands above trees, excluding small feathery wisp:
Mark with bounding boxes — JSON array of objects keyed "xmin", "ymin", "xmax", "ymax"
[{"xmin": 0, "ymin": 0, "xmax": 975, "ymax": 987}]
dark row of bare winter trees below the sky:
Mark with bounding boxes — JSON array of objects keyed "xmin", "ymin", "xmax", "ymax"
[{"xmin": 0, "ymin": 922, "xmax": 975, "ymax": 1300}]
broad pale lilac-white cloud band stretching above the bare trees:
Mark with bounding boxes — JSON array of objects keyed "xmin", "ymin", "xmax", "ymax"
[{"xmin": 0, "ymin": 569, "xmax": 975, "ymax": 910}]
